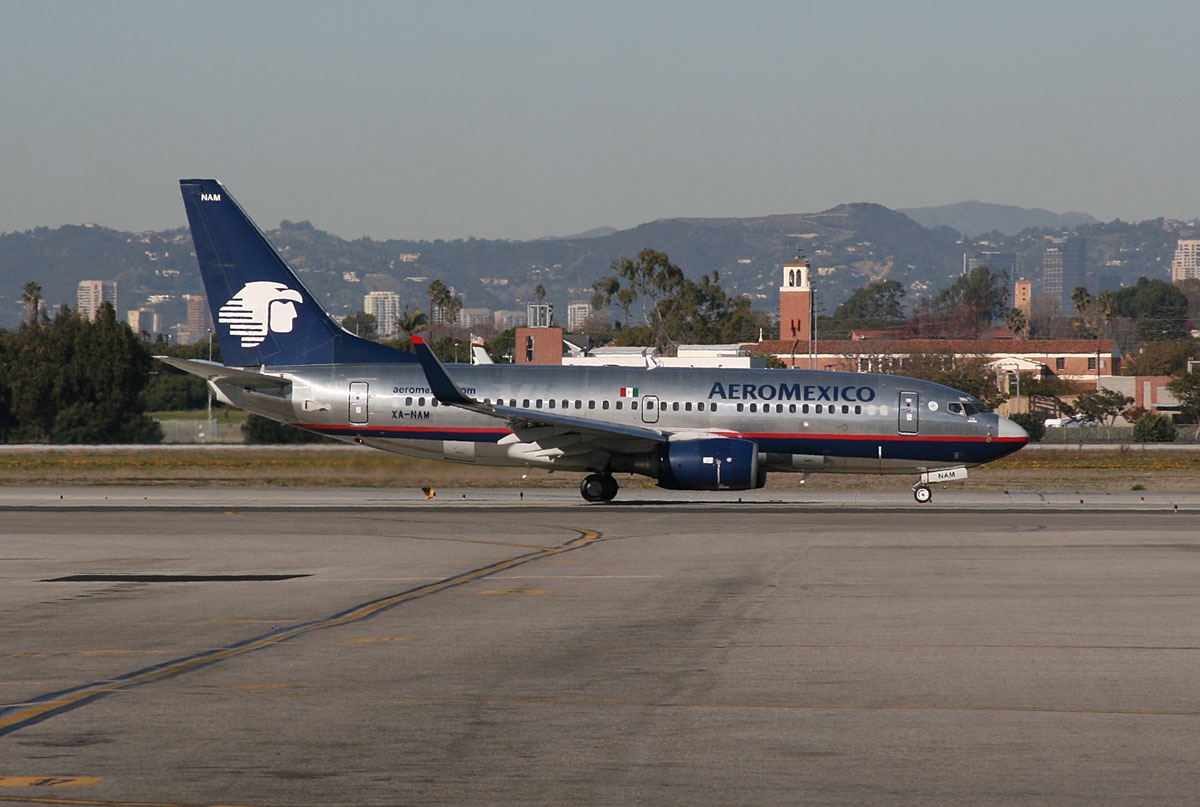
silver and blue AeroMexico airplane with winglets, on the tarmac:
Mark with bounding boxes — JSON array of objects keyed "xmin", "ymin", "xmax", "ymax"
[{"xmin": 156, "ymin": 179, "xmax": 1028, "ymax": 503}]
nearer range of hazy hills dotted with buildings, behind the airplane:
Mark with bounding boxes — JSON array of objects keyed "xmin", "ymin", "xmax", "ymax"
[{"xmin": 0, "ymin": 203, "xmax": 1188, "ymax": 338}]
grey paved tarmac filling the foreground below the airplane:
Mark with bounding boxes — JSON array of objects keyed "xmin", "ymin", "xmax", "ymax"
[{"xmin": 0, "ymin": 489, "xmax": 1200, "ymax": 806}]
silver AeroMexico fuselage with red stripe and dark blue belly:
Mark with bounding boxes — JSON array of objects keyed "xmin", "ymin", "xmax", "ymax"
[{"xmin": 220, "ymin": 364, "xmax": 1026, "ymax": 476}]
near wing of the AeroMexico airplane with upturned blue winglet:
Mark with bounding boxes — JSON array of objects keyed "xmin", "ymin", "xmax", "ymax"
[{"xmin": 413, "ymin": 336, "xmax": 668, "ymax": 450}]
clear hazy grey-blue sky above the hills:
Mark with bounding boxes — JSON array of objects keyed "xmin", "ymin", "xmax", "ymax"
[{"xmin": 0, "ymin": 0, "xmax": 1200, "ymax": 239}]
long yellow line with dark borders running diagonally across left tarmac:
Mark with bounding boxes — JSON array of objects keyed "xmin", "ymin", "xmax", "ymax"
[{"xmin": 0, "ymin": 527, "xmax": 601, "ymax": 736}]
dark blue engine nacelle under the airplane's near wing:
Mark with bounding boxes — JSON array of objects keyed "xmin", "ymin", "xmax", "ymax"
[{"xmin": 658, "ymin": 437, "xmax": 767, "ymax": 490}]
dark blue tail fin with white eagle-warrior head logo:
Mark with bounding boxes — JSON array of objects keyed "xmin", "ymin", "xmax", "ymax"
[{"xmin": 179, "ymin": 179, "xmax": 416, "ymax": 367}]
